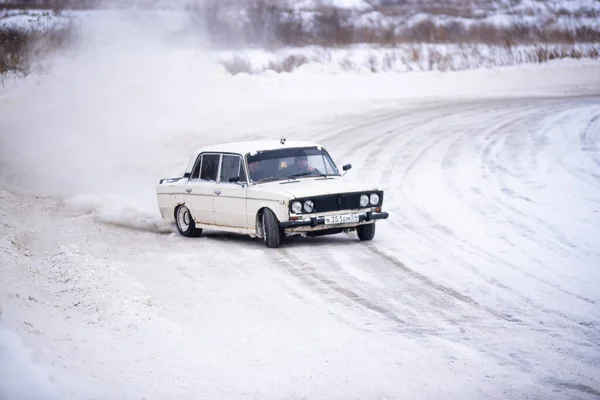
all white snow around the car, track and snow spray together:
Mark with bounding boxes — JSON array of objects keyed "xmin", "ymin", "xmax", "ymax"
[{"xmin": 0, "ymin": 9, "xmax": 600, "ymax": 400}]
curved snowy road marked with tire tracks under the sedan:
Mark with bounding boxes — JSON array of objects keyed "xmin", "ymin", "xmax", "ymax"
[{"xmin": 0, "ymin": 89, "xmax": 600, "ymax": 399}]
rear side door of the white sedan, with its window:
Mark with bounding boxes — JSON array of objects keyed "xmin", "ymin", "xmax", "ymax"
[{"xmin": 184, "ymin": 153, "xmax": 221, "ymax": 225}]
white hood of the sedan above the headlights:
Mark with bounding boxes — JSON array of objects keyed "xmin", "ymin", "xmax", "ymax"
[{"xmin": 253, "ymin": 177, "xmax": 378, "ymax": 199}]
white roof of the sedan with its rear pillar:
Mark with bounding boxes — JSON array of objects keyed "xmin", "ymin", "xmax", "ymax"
[{"xmin": 185, "ymin": 140, "xmax": 323, "ymax": 173}]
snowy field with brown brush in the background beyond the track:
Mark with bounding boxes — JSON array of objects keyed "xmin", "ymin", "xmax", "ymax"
[{"xmin": 0, "ymin": 0, "xmax": 600, "ymax": 74}]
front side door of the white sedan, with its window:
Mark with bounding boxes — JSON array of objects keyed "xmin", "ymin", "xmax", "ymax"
[{"xmin": 214, "ymin": 154, "xmax": 248, "ymax": 228}]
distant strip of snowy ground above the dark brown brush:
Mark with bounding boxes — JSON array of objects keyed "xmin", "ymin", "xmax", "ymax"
[{"xmin": 0, "ymin": 0, "xmax": 600, "ymax": 29}]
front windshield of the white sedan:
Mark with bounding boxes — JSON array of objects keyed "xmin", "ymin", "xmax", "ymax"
[{"xmin": 247, "ymin": 147, "xmax": 340, "ymax": 182}]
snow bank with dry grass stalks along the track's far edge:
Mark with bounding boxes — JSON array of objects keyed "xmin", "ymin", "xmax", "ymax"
[{"xmin": 214, "ymin": 43, "xmax": 600, "ymax": 74}]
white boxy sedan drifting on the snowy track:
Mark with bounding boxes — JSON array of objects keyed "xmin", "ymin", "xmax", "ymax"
[{"xmin": 156, "ymin": 139, "xmax": 388, "ymax": 247}]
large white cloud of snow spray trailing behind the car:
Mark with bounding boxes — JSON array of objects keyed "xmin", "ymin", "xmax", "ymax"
[{"xmin": 0, "ymin": 11, "xmax": 225, "ymax": 225}]
